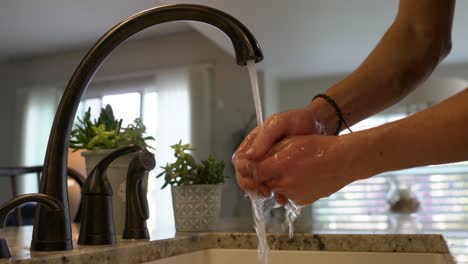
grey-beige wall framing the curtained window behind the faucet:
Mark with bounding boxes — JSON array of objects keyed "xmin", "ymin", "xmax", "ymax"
[{"xmin": 0, "ymin": 31, "xmax": 262, "ymax": 216}]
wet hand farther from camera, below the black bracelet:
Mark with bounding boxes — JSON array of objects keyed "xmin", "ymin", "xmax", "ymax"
[{"xmin": 232, "ymin": 107, "xmax": 323, "ymax": 196}]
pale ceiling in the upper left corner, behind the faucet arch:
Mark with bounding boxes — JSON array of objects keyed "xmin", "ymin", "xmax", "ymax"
[{"xmin": 0, "ymin": 0, "xmax": 193, "ymax": 60}]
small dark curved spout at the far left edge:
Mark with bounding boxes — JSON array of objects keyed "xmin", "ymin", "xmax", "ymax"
[{"xmin": 0, "ymin": 193, "xmax": 63, "ymax": 259}]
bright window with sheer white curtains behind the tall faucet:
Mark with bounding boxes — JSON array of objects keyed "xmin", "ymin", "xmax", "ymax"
[{"xmin": 21, "ymin": 65, "xmax": 212, "ymax": 237}]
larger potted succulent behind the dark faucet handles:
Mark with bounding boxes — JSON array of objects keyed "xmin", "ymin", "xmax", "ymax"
[{"xmin": 69, "ymin": 105, "xmax": 154, "ymax": 234}]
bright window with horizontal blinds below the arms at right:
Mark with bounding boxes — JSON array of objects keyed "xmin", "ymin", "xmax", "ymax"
[{"xmin": 313, "ymin": 111, "xmax": 468, "ymax": 263}]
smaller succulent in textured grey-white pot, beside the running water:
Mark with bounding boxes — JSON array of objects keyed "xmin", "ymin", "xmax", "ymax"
[{"xmin": 157, "ymin": 141, "xmax": 227, "ymax": 232}]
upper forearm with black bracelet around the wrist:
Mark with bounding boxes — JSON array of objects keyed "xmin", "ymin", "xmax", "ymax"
[{"xmin": 308, "ymin": 0, "xmax": 454, "ymax": 133}]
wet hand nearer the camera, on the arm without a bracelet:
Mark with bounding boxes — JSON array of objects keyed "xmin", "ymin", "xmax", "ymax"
[{"xmin": 254, "ymin": 135, "xmax": 367, "ymax": 205}]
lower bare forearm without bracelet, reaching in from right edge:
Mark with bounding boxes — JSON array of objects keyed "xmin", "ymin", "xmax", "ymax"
[{"xmin": 343, "ymin": 89, "xmax": 468, "ymax": 178}]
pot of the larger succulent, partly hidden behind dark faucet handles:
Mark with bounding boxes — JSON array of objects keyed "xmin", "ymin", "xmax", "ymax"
[{"xmin": 81, "ymin": 149, "xmax": 148, "ymax": 235}]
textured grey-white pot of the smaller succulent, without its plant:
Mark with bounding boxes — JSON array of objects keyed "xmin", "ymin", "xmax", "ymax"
[{"xmin": 171, "ymin": 184, "xmax": 223, "ymax": 232}]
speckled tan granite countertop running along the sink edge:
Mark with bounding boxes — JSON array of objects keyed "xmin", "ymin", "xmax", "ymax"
[{"xmin": 0, "ymin": 226, "xmax": 449, "ymax": 264}]
